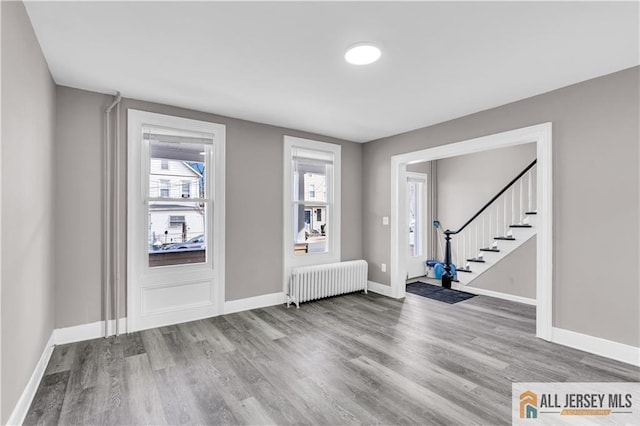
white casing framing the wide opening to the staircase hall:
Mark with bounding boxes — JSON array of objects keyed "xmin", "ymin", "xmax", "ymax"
[{"xmin": 390, "ymin": 122, "xmax": 553, "ymax": 340}]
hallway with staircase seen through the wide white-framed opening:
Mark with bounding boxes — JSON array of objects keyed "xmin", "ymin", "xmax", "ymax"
[{"xmin": 406, "ymin": 143, "xmax": 537, "ymax": 304}]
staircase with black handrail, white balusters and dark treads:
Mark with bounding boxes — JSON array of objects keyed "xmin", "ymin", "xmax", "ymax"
[{"xmin": 442, "ymin": 160, "xmax": 537, "ymax": 289}]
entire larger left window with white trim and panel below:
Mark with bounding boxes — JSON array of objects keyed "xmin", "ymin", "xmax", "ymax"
[{"xmin": 126, "ymin": 109, "xmax": 226, "ymax": 331}]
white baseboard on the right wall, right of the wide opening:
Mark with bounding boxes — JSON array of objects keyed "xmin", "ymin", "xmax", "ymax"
[{"xmin": 551, "ymin": 327, "xmax": 640, "ymax": 367}]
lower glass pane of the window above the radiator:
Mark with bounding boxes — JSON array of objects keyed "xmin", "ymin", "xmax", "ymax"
[{"xmin": 293, "ymin": 203, "xmax": 329, "ymax": 255}]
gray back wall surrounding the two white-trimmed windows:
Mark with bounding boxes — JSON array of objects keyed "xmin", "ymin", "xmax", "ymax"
[{"xmin": 55, "ymin": 87, "xmax": 362, "ymax": 327}]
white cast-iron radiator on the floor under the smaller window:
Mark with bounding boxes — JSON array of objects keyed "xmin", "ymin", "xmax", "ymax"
[{"xmin": 287, "ymin": 260, "xmax": 368, "ymax": 308}]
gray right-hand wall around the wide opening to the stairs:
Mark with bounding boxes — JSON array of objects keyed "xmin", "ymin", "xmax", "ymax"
[{"xmin": 362, "ymin": 67, "xmax": 640, "ymax": 347}]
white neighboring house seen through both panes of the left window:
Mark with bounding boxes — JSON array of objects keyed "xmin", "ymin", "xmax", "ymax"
[{"xmin": 145, "ymin": 129, "xmax": 209, "ymax": 266}]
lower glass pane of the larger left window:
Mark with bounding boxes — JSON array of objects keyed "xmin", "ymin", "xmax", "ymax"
[{"xmin": 148, "ymin": 201, "xmax": 207, "ymax": 267}]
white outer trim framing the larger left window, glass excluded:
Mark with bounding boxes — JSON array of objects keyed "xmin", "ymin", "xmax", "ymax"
[{"xmin": 127, "ymin": 109, "xmax": 226, "ymax": 333}]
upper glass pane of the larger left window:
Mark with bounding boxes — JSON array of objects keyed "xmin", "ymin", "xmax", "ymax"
[{"xmin": 145, "ymin": 133, "xmax": 206, "ymax": 198}]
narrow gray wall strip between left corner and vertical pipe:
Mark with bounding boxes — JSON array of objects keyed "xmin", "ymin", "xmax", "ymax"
[{"xmin": 54, "ymin": 86, "xmax": 111, "ymax": 328}]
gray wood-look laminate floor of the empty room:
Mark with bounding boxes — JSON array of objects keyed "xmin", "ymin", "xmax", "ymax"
[{"xmin": 25, "ymin": 293, "xmax": 640, "ymax": 425}]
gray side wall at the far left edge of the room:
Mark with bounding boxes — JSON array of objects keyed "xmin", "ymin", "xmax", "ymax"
[{"xmin": 0, "ymin": 2, "xmax": 55, "ymax": 424}]
